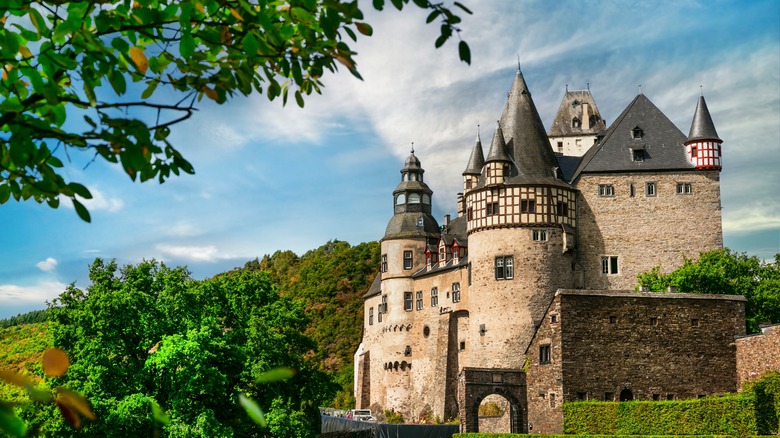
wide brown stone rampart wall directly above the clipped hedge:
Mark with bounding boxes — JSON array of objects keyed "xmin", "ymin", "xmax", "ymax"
[{"xmin": 556, "ymin": 291, "xmax": 745, "ymax": 401}]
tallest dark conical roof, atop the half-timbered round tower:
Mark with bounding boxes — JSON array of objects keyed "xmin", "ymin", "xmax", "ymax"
[{"xmin": 499, "ymin": 68, "xmax": 569, "ymax": 187}]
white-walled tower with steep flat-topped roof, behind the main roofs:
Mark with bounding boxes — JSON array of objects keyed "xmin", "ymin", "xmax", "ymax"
[{"xmin": 548, "ymin": 88, "xmax": 607, "ymax": 157}]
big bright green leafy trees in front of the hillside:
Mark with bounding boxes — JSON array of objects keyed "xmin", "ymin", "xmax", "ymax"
[{"xmin": 35, "ymin": 260, "xmax": 336, "ymax": 437}]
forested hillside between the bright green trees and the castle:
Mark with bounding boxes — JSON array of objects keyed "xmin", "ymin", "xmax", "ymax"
[{"xmin": 243, "ymin": 240, "xmax": 379, "ymax": 408}]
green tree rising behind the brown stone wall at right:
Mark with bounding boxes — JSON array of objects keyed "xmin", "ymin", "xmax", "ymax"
[{"xmin": 637, "ymin": 248, "xmax": 780, "ymax": 333}]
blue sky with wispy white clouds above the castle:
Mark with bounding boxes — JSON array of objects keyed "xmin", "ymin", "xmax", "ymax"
[{"xmin": 0, "ymin": 0, "xmax": 780, "ymax": 318}]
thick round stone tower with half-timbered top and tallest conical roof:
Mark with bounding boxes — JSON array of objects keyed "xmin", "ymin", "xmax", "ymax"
[{"xmin": 461, "ymin": 69, "xmax": 577, "ymax": 368}]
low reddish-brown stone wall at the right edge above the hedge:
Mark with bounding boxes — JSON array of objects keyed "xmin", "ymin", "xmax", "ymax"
[{"xmin": 736, "ymin": 325, "xmax": 780, "ymax": 391}]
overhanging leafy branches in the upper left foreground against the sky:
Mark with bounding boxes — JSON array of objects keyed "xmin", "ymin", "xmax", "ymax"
[{"xmin": 0, "ymin": 0, "xmax": 471, "ymax": 221}]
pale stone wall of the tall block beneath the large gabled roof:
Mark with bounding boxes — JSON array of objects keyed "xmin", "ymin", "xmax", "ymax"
[{"xmin": 577, "ymin": 170, "xmax": 723, "ymax": 290}]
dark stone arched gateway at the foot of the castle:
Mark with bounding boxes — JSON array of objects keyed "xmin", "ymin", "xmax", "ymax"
[{"xmin": 458, "ymin": 368, "xmax": 528, "ymax": 433}]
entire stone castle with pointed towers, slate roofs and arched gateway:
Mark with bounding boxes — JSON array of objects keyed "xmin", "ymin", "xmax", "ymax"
[{"xmin": 355, "ymin": 69, "xmax": 745, "ymax": 433}]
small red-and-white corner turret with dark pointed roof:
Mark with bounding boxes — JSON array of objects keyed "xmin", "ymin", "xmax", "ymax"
[{"xmin": 685, "ymin": 96, "xmax": 723, "ymax": 170}]
